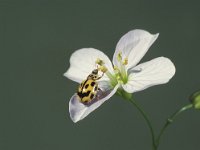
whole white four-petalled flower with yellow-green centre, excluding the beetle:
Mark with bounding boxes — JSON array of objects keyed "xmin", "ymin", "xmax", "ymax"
[{"xmin": 64, "ymin": 29, "xmax": 175, "ymax": 122}]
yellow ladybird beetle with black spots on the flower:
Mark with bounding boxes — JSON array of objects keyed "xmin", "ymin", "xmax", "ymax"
[{"xmin": 77, "ymin": 69, "xmax": 104, "ymax": 104}]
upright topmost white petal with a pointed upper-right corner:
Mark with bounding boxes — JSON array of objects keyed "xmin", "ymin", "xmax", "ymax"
[{"xmin": 113, "ymin": 29, "xmax": 159, "ymax": 68}]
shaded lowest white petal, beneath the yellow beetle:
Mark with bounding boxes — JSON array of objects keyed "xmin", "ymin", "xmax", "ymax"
[{"xmin": 69, "ymin": 85, "xmax": 119, "ymax": 122}]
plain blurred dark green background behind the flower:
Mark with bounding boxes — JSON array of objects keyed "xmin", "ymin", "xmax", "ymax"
[{"xmin": 0, "ymin": 0, "xmax": 200, "ymax": 150}]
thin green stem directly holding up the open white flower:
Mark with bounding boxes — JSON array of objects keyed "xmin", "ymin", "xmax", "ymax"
[{"xmin": 129, "ymin": 98, "xmax": 157, "ymax": 150}]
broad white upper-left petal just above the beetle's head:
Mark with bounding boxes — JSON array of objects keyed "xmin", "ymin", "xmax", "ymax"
[{"xmin": 64, "ymin": 48, "xmax": 113, "ymax": 83}]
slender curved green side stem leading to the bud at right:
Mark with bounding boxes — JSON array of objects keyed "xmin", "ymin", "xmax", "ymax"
[{"xmin": 156, "ymin": 104, "xmax": 193, "ymax": 149}]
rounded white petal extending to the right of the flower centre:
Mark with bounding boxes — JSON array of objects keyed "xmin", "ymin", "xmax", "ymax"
[{"xmin": 122, "ymin": 57, "xmax": 176, "ymax": 93}]
